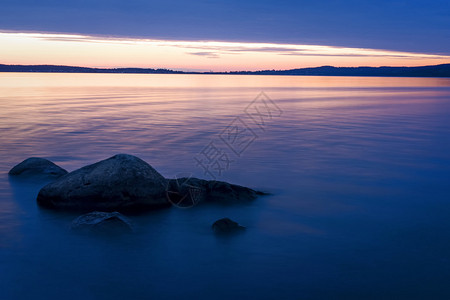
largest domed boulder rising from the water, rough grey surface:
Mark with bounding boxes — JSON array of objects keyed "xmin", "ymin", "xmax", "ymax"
[{"xmin": 37, "ymin": 154, "xmax": 169, "ymax": 211}]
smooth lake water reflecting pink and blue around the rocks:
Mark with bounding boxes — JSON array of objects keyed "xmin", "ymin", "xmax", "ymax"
[{"xmin": 0, "ymin": 73, "xmax": 450, "ymax": 299}]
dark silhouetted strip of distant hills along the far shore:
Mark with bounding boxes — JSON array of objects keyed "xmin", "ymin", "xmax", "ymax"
[{"xmin": 0, "ymin": 64, "xmax": 450, "ymax": 77}]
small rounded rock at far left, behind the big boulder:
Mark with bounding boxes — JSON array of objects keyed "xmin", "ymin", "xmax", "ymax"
[{"xmin": 8, "ymin": 157, "xmax": 68, "ymax": 178}]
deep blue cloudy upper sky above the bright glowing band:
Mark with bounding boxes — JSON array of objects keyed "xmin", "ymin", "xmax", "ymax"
[{"xmin": 0, "ymin": 0, "xmax": 450, "ymax": 55}]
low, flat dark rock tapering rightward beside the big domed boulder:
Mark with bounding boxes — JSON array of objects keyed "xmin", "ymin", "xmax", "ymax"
[{"xmin": 167, "ymin": 177, "xmax": 266, "ymax": 207}]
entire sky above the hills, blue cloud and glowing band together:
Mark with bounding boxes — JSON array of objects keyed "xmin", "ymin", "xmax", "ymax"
[{"xmin": 0, "ymin": 0, "xmax": 450, "ymax": 71}]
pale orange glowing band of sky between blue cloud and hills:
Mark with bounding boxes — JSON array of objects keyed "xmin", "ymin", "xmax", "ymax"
[{"xmin": 0, "ymin": 32, "xmax": 450, "ymax": 71}]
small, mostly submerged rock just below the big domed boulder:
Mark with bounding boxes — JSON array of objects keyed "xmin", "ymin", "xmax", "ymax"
[{"xmin": 71, "ymin": 211, "xmax": 133, "ymax": 233}]
